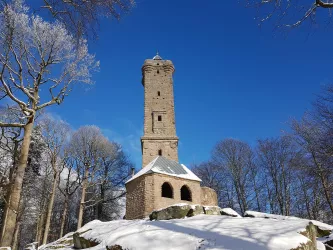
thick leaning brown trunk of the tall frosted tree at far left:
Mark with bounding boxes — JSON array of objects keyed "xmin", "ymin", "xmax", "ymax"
[{"xmin": 1, "ymin": 116, "xmax": 34, "ymax": 247}]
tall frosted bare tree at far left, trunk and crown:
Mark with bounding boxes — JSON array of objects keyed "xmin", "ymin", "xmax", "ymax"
[{"xmin": 0, "ymin": 2, "xmax": 98, "ymax": 246}]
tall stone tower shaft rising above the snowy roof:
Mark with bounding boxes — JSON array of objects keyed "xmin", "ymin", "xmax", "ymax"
[{"xmin": 141, "ymin": 53, "xmax": 178, "ymax": 167}]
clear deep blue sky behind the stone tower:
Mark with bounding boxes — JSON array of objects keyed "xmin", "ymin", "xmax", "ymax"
[{"xmin": 48, "ymin": 0, "xmax": 333, "ymax": 169}]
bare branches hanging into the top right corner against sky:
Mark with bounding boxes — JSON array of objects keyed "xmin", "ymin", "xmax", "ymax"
[{"xmin": 245, "ymin": 0, "xmax": 333, "ymax": 28}]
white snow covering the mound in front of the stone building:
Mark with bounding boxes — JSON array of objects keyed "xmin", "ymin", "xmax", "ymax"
[{"xmin": 40, "ymin": 215, "xmax": 329, "ymax": 250}]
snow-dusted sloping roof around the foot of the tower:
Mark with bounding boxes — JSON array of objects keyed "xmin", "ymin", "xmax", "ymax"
[{"xmin": 126, "ymin": 156, "xmax": 201, "ymax": 183}]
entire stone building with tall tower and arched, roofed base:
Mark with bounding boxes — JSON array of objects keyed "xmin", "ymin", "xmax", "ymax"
[{"xmin": 126, "ymin": 54, "xmax": 217, "ymax": 219}]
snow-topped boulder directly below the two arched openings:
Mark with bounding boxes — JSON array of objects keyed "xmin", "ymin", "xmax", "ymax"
[{"xmin": 149, "ymin": 204, "xmax": 191, "ymax": 220}]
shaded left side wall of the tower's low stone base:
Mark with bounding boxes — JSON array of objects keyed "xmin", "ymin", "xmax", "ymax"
[{"xmin": 125, "ymin": 176, "xmax": 146, "ymax": 220}]
